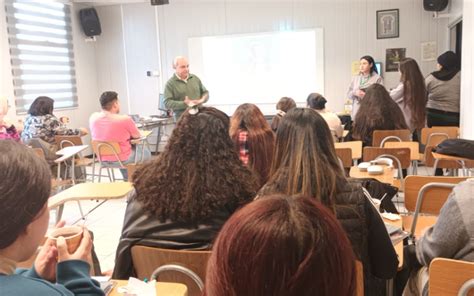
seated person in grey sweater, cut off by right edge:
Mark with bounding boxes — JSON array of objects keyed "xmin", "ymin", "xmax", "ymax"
[{"xmin": 404, "ymin": 179, "xmax": 474, "ymax": 295}]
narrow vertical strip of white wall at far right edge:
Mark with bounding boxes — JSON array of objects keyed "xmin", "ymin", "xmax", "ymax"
[{"xmin": 461, "ymin": 0, "xmax": 474, "ymax": 140}]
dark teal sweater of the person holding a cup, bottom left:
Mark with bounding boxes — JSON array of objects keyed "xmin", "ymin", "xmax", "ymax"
[{"xmin": 0, "ymin": 260, "xmax": 104, "ymax": 296}]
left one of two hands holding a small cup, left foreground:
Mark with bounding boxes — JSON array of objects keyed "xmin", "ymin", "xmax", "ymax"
[{"xmin": 34, "ymin": 221, "xmax": 66, "ymax": 283}]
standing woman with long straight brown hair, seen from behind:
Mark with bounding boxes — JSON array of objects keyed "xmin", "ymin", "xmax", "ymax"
[{"xmin": 390, "ymin": 58, "xmax": 427, "ymax": 139}]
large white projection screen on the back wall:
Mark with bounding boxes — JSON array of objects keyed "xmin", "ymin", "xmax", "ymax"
[{"xmin": 189, "ymin": 29, "xmax": 324, "ymax": 114}]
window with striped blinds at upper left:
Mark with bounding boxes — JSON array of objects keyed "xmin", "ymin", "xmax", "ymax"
[{"xmin": 5, "ymin": 0, "xmax": 77, "ymax": 113}]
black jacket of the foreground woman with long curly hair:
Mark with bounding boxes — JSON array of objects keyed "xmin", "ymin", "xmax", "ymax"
[{"xmin": 112, "ymin": 194, "xmax": 233, "ymax": 279}]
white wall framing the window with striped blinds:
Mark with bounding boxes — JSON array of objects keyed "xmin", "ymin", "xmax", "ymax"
[{"xmin": 0, "ymin": 0, "xmax": 99, "ymax": 149}]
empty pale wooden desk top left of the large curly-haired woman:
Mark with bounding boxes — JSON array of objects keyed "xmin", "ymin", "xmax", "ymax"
[{"xmin": 48, "ymin": 182, "xmax": 133, "ymax": 208}]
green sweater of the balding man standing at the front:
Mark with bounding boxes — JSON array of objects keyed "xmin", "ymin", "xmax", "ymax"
[{"xmin": 164, "ymin": 74, "xmax": 209, "ymax": 118}]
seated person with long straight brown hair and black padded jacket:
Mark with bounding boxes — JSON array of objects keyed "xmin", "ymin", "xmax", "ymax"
[{"xmin": 259, "ymin": 108, "xmax": 398, "ymax": 295}]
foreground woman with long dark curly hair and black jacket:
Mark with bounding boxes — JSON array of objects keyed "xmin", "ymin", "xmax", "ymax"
[{"xmin": 113, "ymin": 107, "xmax": 257, "ymax": 279}]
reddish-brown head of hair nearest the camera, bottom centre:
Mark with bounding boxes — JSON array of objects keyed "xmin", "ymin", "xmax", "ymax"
[{"xmin": 204, "ymin": 195, "xmax": 356, "ymax": 296}]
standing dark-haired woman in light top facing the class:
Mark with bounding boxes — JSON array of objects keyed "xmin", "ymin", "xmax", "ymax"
[{"xmin": 347, "ymin": 55, "xmax": 383, "ymax": 120}]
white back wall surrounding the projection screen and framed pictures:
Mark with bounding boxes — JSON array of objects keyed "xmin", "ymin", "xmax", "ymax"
[{"xmin": 91, "ymin": 0, "xmax": 452, "ymax": 112}]
